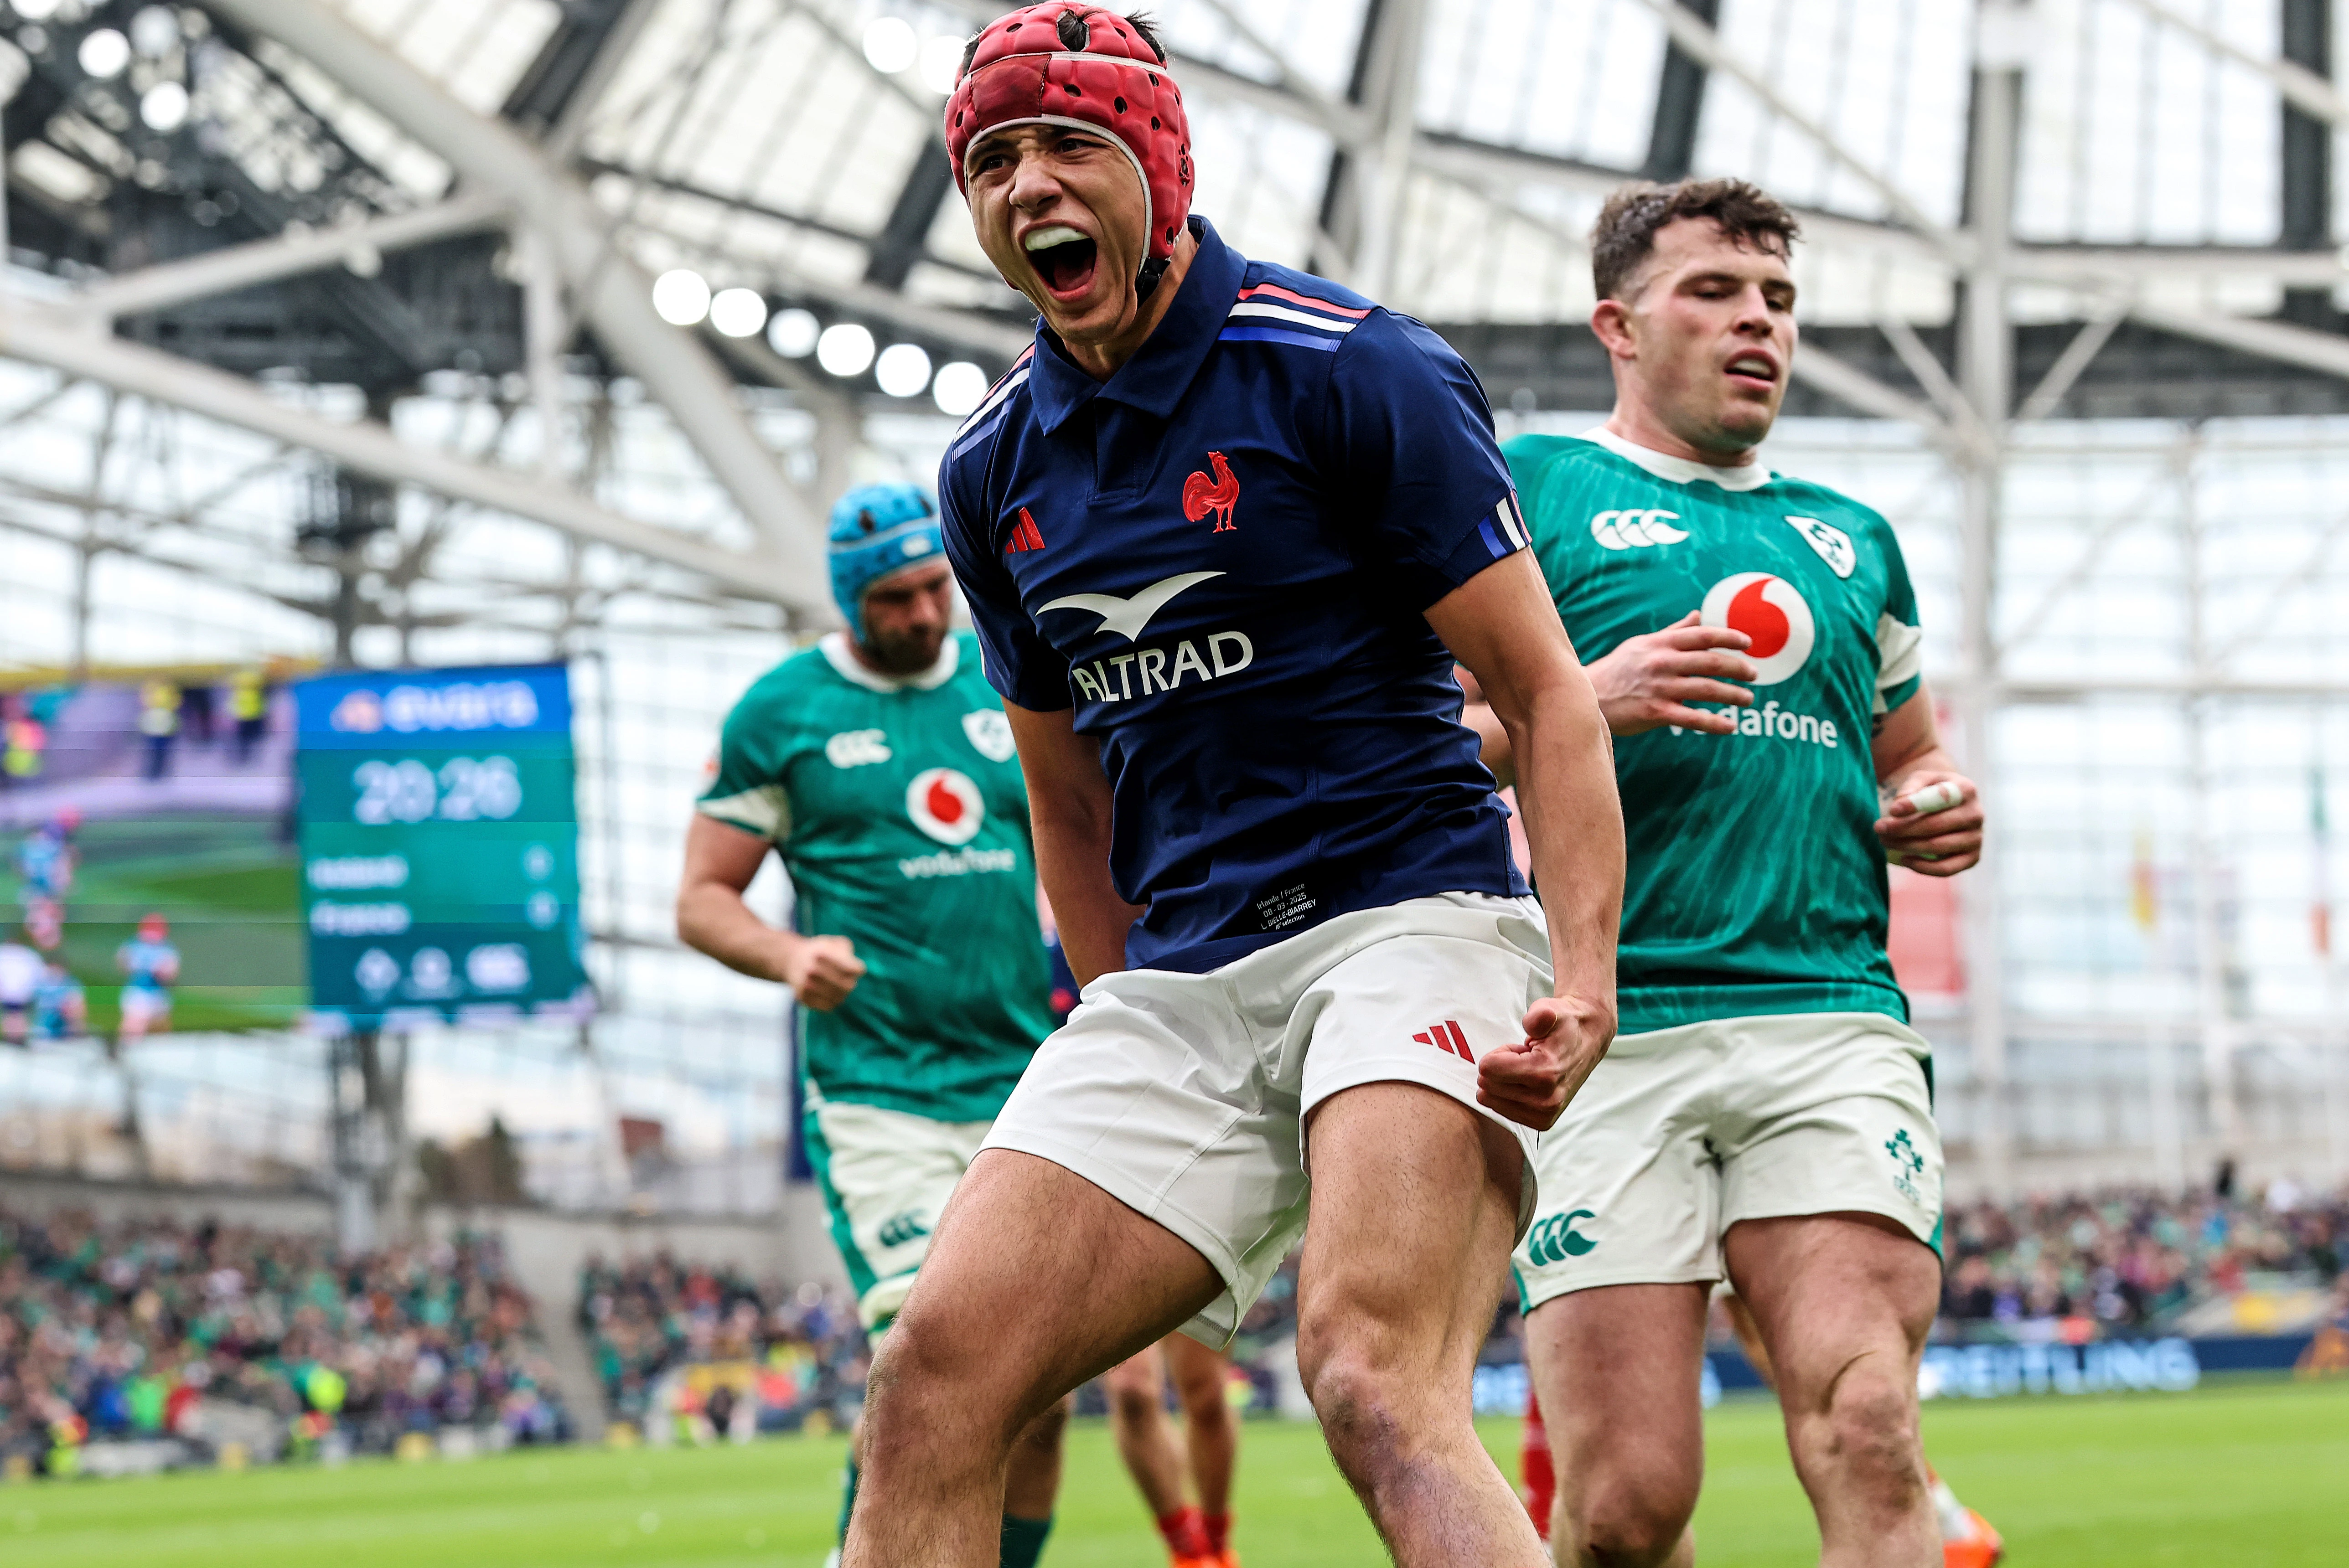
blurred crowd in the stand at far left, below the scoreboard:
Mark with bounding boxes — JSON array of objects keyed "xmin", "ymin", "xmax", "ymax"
[{"xmin": 0, "ymin": 1211, "xmax": 569, "ymax": 1474}]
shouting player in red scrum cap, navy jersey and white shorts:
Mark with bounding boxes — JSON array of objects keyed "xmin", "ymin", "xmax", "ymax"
[{"xmin": 846, "ymin": 0, "xmax": 1623, "ymax": 1568}]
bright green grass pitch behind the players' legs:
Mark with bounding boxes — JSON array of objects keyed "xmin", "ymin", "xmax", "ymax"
[{"xmin": 0, "ymin": 1382, "xmax": 2349, "ymax": 1568}]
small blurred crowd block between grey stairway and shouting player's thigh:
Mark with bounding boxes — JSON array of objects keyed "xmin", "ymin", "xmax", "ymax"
[{"xmin": 578, "ymin": 1251, "xmax": 871, "ymax": 1441}]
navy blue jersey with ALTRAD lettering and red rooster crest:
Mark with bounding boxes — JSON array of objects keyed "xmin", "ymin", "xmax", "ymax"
[{"xmin": 937, "ymin": 218, "xmax": 1525, "ymax": 972}]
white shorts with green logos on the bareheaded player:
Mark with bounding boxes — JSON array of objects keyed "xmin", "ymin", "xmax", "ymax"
[{"xmin": 1515, "ymin": 1012, "xmax": 1940, "ymax": 1310}]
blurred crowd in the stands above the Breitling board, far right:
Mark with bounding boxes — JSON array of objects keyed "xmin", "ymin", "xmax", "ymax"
[{"xmin": 1943, "ymin": 1174, "xmax": 2349, "ymax": 1331}]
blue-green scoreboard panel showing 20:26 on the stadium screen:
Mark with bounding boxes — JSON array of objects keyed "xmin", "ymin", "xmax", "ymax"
[{"xmin": 294, "ymin": 664, "xmax": 594, "ymax": 1031}]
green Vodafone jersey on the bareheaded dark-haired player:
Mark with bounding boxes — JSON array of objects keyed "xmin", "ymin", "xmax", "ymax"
[{"xmin": 1501, "ymin": 432, "xmax": 1919, "ymax": 1035}]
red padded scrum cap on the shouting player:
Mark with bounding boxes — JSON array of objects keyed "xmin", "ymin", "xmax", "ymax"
[{"xmin": 947, "ymin": 0, "xmax": 1191, "ymax": 296}]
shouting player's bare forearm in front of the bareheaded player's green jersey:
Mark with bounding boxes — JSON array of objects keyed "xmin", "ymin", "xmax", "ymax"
[{"xmin": 1496, "ymin": 669, "xmax": 1623, "ymax": 1016}]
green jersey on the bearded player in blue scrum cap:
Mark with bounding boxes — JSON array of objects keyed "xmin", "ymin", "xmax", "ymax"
[{"xmin": 700, "ymin": 631, "xmax": 1052, "ymax": 1122}]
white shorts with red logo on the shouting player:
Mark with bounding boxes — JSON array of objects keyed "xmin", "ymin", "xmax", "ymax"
[{"xmin": 987, "ymin": 892, "xmax": 1550, "ymax": 1345}]
